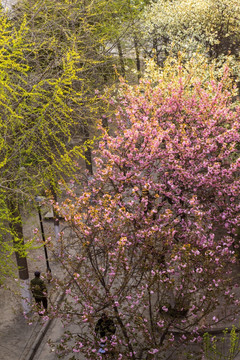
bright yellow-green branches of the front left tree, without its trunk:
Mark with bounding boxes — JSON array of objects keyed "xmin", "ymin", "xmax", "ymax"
[{"xmin": 0, "ymin": 16, "xmax": 83, "ymax": 192}]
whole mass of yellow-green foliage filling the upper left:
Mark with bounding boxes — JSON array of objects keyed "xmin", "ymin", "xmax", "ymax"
[{"xmin": 0, "ymin": 0, "xmax": 146, "ymax": 282}]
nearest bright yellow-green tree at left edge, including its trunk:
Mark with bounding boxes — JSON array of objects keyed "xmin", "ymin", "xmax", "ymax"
[{"xmin": 0, "ymin": 6, "xmax": 91, "ymax": 310}]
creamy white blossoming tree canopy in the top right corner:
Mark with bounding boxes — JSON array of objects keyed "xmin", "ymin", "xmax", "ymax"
[{"xmin": 140, "ymin": 0, "xmax": 240, "ymax": 69}]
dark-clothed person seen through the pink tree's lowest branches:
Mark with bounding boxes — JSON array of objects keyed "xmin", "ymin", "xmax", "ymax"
[{"xmin": 95, "ymin": 313, "xmax": 116, "ymax": 354}]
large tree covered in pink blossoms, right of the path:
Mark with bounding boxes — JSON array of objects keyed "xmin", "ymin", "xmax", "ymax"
[{"xmin": 52, "ymin": 57, "xmax": 240, "ymax": 360}]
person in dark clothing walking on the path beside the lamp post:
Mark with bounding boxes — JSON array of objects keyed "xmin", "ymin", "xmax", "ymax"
[{"xmin": 30, "ymin": 271, "xmax": 48, "ymax": 311}]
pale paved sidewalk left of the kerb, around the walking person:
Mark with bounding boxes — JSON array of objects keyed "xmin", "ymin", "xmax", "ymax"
[{"xmin": 0, "ymin": 211, "xmax": 61, "ymax": 360}]
